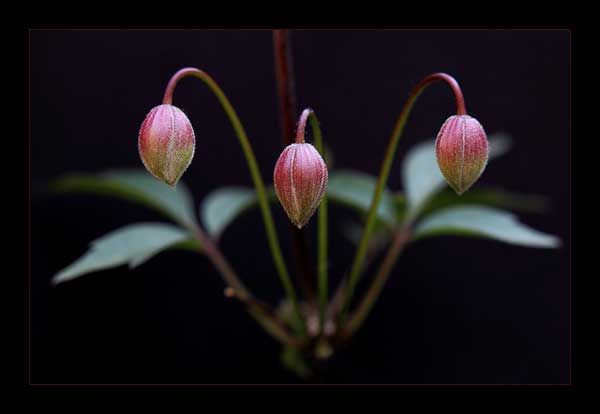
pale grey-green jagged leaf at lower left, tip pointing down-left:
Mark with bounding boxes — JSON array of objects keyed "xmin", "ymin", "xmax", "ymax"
[{"xmin": 52, "ymin": 223, "xmax": 198, "ymax": 284}]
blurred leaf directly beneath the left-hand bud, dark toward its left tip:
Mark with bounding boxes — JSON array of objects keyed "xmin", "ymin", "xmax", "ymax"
[{"xmin": 50, "ymin": 169, "xmax": 196, "ymax": 228}]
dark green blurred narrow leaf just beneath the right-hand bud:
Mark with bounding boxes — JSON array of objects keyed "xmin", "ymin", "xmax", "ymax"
[{"xmin": 420, "ymin": 188, "xmax": 549, "ymax": 216}]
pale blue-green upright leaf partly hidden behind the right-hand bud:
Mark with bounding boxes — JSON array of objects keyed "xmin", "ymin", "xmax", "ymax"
[{"xmin": 402, "ymin": 133, "xmax": 510, "ymax": 215}]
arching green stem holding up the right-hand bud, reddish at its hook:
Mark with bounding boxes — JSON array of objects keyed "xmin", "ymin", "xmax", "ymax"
[{"xmin": 340, "ymin": 73, "xmax": 467, "ymax": 326}]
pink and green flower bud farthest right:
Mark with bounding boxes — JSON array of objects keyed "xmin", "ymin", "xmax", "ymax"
[{"xmin": 435, "ymin": 115, "xmax": 488, "ymax": 195}]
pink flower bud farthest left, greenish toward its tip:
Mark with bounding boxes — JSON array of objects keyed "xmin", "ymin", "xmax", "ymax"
[{"xmin": 138, "ymin": 104, "xmax": 196, "ymax": 186}]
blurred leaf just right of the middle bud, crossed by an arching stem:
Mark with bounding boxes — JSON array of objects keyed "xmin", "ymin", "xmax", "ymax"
[{"xmin": 327, "ymin": 170, "xmax": 396, "ymax": 226}]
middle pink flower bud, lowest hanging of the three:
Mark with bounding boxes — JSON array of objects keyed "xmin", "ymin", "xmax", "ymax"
[{"xmin": 273, "ymin": 143, "xmax": 327, "ymax": 228}]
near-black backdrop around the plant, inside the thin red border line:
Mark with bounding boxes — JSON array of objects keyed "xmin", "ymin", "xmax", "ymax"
[{"xmin": 30, "ymin": 30, "xmax": 571, "ymax": 383}]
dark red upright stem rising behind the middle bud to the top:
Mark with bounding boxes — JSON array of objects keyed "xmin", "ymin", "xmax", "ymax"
[{"xmin": 273, "ymin": 30, "xmax": 316, "ymax": 303}]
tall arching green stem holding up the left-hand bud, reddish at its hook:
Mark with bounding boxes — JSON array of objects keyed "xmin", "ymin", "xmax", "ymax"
[{"xmin": 163, "ymin": 68, "xmax": 305, "ymax": 335}]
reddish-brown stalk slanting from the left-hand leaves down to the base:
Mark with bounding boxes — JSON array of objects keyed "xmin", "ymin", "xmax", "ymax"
[{"xmin": 193, "ymin": 226, "xmax": 299, "ymax": 347}]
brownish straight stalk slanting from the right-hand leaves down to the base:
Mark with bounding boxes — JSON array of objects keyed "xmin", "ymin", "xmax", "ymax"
[{"xmin": 343, "ymin": 226, "xmax": 411, "ymax": 338}]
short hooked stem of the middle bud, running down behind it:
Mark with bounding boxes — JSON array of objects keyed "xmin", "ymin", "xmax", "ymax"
[{"xmin": 296, "ymin": 108, "xmax": 327, "ymax": 333}]
